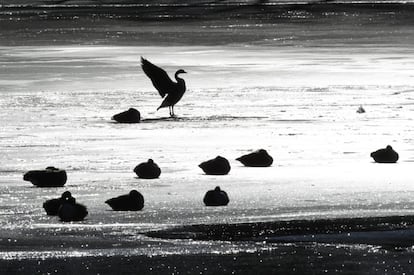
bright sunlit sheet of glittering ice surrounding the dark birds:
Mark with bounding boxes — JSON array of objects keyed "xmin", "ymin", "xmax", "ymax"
[{"xmin": 0, "ymin": 4, "xmax": 414, "ymax": 264}]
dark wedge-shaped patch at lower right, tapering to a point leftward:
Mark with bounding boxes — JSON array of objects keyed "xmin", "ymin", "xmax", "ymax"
[{"xmin": 145, "ymin": 216, "xmax": 414, "ymax": 250}]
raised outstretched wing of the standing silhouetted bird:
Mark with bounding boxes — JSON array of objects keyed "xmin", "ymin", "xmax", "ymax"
[{"xmin": 141, "ymin": 57, "xmax": 175, "ymax": 97}]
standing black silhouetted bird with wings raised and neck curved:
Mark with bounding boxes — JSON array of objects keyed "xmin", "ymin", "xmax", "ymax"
[{"xmin": 141, "ymin": 57, "xmax": 186, "ymax": 117}]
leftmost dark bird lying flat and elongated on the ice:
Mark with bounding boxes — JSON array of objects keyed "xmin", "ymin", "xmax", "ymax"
[{"xmin": 23, "ymin": 166, "xmax": 67, "ymax": 187}]
